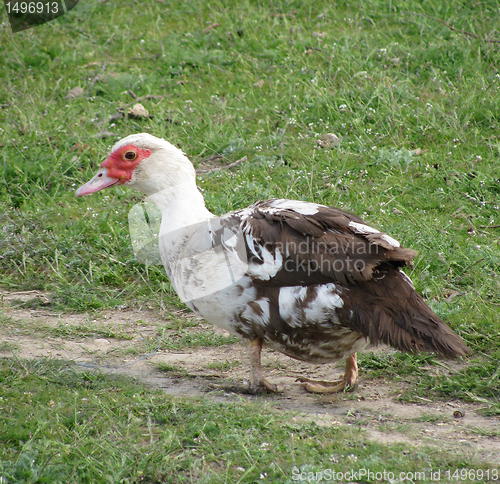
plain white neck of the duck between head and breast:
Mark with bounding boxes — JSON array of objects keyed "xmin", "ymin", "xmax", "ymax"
[{"xmin": 149, "ymin": 180, "xmax": 214, "ymax": 233}]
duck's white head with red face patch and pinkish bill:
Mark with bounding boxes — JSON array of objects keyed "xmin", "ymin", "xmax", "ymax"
[{"xmin": 75, "ymin": 133, "xmax": 196, "ymax": 197}]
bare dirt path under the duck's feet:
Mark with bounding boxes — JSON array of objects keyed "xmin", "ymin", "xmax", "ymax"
[{"xmin": 0, "ymin": 291, "xmax": 500, "ymax": 464}]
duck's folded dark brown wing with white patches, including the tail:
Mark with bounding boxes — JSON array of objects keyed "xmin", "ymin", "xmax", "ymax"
[{"xmin": 235, "ymin": 199, "xmax": 470, "ymax": 357}]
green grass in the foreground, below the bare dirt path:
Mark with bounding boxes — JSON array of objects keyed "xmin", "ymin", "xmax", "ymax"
[{"xmin": 0, "ymin": 359, "xmax": 488, "ymax": 484}]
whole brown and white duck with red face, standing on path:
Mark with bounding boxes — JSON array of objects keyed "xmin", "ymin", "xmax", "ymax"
[{"xmin": 76, "ymin": 133, "xmax": 470, "ymax": 392}]
